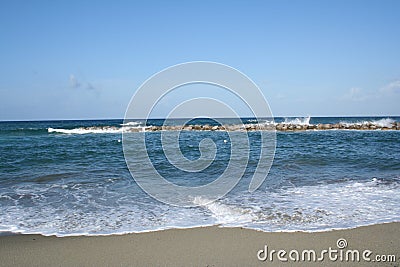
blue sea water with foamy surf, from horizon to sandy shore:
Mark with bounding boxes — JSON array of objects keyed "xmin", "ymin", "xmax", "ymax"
[{"xmin": 0, "ymin": 117, "xmax": 400, "ymax": 236}]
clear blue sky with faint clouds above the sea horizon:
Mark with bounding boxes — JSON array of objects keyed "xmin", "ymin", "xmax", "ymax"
[{"xmin": 0, "ymin": 0, "xmax": 400, "ymax": 120}]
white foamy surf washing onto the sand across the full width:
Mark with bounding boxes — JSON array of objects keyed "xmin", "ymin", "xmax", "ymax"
[{"xmin": 0, "ymin": 178, "xmax": 400, "ymax": 236}]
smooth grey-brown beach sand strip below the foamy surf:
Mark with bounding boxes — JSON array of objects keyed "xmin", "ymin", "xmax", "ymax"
[{"xmin": 0, "ymin": 223, "xmax": 400, "ymax": 266}]
